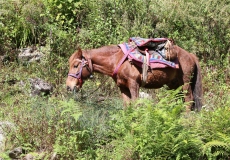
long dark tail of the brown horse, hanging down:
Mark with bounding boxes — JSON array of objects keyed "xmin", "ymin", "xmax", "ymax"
[{"xmin": 192, "ymin": 55, "xmax": 203, "ymax": 111}]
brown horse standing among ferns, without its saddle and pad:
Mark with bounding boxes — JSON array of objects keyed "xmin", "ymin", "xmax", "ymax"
[{"xmin": 66, "ymin": 41, "xmax": 202, "ymax": 111}]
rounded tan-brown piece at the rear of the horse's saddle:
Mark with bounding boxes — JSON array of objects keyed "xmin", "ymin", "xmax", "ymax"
[{"xmin": 165, "ymin": 39, "xmax": 178, "ymax": 60}]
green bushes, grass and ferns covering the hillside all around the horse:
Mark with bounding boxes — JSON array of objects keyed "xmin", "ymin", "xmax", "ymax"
[{"xmin": 0, "ymin": 0, "xmax": 230, "ymax": 160}]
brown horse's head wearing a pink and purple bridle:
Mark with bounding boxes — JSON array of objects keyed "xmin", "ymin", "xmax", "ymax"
[{"xmin": 66, "ymin": 48, "xmax": 92, "ymax": 91}]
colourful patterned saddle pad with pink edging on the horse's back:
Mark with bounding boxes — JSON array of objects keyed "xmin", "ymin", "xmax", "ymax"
[{"xmin": 119, "ymin": 39, "xmax": 179, "ymax": 68}]
